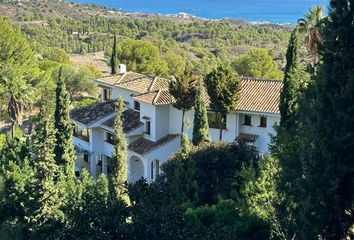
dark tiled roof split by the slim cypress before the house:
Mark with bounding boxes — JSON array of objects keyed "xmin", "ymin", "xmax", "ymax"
[{"xmin": 103, "ymin": 109, "xmax": 143, "ymax": 133}]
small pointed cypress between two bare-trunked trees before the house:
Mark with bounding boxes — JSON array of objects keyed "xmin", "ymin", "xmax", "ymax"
[{"xmin": 192, "ymin": 81, "xmax": 210, "ymax": 145}]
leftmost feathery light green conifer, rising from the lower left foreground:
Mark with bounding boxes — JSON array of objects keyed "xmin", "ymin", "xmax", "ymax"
[{"xmin": 30, "ymin": 106, "xmax": 64, "ymax": 237}]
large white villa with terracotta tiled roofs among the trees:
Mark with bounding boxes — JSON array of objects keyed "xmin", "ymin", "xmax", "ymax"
[{"xmin": 71, "ymin": 64, "xmax": 282, "ymax": 182}]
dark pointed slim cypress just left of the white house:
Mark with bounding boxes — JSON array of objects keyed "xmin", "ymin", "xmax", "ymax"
[{"xmin": 54, "ymin": 68, "xmax": 75, "ymax": 177}]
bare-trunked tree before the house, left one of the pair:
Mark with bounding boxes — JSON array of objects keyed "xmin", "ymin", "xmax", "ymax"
[{"xmin": 169, "ymin": 67, "xmax": 199, "ymax": 140}]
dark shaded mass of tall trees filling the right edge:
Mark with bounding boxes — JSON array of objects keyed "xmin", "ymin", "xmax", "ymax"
[{"xmin": 273, "ymin": 0, "xmax": 354, "ymax": 239}]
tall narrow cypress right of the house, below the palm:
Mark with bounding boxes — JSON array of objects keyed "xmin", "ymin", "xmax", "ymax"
[{"xmin": 271, "ymin": 24, "xmax": 310, "ymax": 239}]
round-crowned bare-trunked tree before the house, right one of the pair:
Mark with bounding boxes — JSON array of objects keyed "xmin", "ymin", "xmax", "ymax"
[{"xmin": 205, "ymin": 65, "xmax": 241, "ymax": 141}]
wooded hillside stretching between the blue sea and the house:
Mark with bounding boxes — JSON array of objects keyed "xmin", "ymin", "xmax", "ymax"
[{"xmin": 0, "ymin": 0, "xmax": 291, "ymax": 74}]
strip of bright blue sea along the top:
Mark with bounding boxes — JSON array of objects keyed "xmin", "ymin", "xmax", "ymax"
[{"xmin": 74, "ymin": 0, "xmax": 329, "ymax": 24}]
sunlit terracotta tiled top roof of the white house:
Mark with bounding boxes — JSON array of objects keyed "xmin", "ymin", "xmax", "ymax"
[{"xmin": 96, "ymin": 72, "xmax": 283, "ymax": 113}]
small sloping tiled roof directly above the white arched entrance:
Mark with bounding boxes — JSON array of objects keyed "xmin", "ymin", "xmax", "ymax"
[{"xmin": 128, "ymin": 134, "xmax": 179, "ymax": 155}]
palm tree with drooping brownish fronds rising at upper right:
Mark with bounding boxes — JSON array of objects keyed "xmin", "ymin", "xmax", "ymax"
[{"xmin": 298, "ymin": 6, "xmax": 324, "ymax": 66}]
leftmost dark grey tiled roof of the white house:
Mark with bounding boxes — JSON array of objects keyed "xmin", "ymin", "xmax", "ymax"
[{"xmin": 70, "ymin": 100, "xmax": 115, "ymax": 126}]
